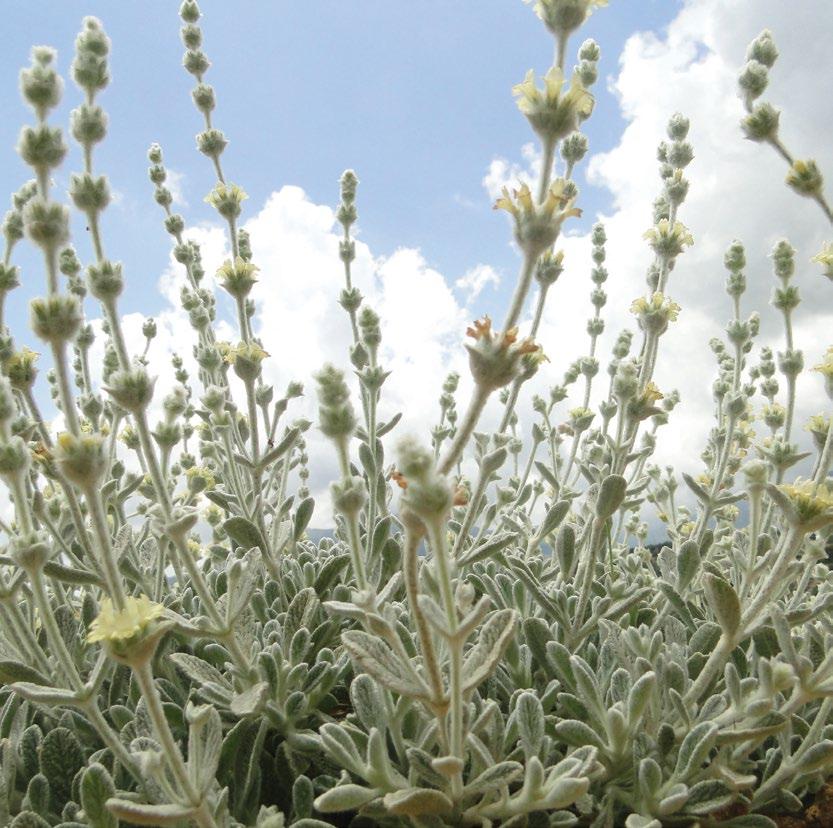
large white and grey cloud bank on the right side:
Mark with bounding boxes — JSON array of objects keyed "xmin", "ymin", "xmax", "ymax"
[{"xmin": 500, "ymin": 0, "xmax": 833, "ymax": 478}]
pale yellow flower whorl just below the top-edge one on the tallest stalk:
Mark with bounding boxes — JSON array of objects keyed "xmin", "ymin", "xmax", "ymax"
[{"xmin": 512, "ymin": 66, "xmax": 593, "ymax": 142}]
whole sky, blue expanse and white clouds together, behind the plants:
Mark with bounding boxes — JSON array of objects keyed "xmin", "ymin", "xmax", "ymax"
[{"xmin": 0, "ymin": 0, "xmax": 833, "ymax": 519}]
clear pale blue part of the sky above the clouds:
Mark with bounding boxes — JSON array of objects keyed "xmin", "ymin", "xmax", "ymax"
[{"xmin": 0, "ymin": 0, "xmax": 680, "ymax": 336}]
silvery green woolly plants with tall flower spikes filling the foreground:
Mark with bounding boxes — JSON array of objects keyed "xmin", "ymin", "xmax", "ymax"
[{"xmin": 0, "ymin": 0, "xmax": 833, "ymax": 828}]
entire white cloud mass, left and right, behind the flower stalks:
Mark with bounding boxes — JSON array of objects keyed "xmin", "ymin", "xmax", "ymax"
[{"xmin": 112, "ymin": 0, "xmax": 833, "ymax": 525}]
